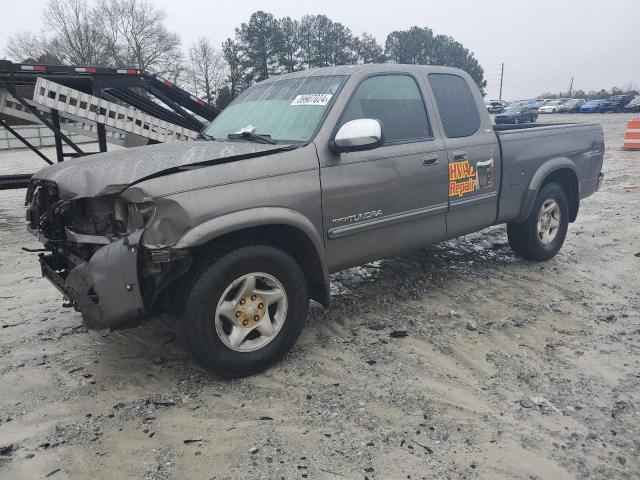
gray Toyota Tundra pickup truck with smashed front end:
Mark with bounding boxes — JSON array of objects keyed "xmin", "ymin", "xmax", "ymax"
[{"xmin": 26, "ymin": 64, "xmax": 604, "ymax": 377}]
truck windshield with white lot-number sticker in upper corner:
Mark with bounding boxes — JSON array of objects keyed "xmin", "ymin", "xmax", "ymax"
[{"xmin": 204, "ymin": 76, "xmax": 345, "ymax": 142}]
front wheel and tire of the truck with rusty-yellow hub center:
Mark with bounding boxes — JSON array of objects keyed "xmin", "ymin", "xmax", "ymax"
[{"xmin": 180, "ymin": 245, "xmax": 309, "ymax": 378}]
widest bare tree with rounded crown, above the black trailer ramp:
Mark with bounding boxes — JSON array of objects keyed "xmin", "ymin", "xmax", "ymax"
[{"xmin": 93, "ymin": 0, "xmax": 182, "ymax": 77}]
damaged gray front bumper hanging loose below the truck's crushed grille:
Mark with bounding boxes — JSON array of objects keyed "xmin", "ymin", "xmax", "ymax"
[{"xmin": 40, "ymin": 230, "xmax": 146, "ymax": 329}]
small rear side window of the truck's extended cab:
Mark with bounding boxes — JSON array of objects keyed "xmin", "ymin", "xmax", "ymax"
[{"xmin": 429, "ymin": 73, "xmax": 480, "ymax": 138}]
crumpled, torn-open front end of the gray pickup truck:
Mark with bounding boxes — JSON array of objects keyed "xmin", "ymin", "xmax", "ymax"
[{"xmin": 27, "ymin": 180, "xmax": 189, "ymax": 329}]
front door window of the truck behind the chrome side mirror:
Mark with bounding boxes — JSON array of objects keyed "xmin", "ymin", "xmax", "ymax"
[{"xmin": 340, "ymin": 75, "xmax": 431, "ymax": 143}]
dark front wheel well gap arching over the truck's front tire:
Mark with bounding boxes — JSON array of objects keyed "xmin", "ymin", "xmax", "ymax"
[{"xmin": 192, "ymin": 224, "xmax": 329, "ymax": 306}]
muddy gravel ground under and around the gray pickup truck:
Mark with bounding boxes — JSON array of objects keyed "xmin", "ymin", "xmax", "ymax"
[{"xmin": 0, "ymin": 114, "xmax": 640, "ymax": 480}]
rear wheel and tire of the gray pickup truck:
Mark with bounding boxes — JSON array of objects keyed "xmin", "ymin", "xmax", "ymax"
[{"xmin": 507, "ymin": 183, "xmax": 569, "ymax": 261}]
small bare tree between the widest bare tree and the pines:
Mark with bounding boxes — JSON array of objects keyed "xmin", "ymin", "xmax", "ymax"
[{"xmin": 189, "ymin": 37, "xmax": 228, "ymax": 104}]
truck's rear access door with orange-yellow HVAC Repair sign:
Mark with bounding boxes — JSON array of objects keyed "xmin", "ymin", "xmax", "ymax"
[{"xmin": 428, "ymin": 73, "xmax": 501, "ymax": 238}]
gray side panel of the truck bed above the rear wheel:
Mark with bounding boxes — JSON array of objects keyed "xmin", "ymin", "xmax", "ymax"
[{"xmin": 493, "ymin": 123, "xmax": 604, "ymax": 223}]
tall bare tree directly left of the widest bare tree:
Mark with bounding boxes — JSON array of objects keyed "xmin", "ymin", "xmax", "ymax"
[{"xmin": 42, "ymin": 0, "xmax": 109, "ymax": 66}]
